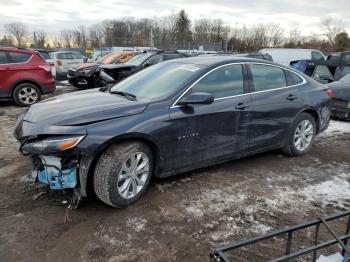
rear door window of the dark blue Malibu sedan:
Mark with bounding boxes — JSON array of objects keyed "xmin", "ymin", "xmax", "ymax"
[{"xmin": 250, "ymin": 64, "xmax": 287, "ymax": 92}]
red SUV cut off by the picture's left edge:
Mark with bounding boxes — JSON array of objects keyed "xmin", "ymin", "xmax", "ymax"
[{"xmin": 0, "ymin": 47, "xmax": 56, "ymax": 106}]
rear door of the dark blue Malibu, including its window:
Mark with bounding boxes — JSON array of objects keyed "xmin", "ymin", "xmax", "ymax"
[{"xmin": 249, "ymin": 63, "xmax": 304, "ymax": 151}]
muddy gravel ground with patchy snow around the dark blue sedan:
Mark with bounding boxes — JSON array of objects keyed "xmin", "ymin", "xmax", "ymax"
[{"xmin": 0, "ymin": 84, "xmax": 350, "ymax": 262}]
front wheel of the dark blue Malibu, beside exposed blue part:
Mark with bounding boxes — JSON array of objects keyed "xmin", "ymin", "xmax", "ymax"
[{"xmin": 93, "ymin": 142, "xmax": 153, "ymax": 208}]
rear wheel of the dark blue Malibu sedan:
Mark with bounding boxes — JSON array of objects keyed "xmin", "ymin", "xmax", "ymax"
[{"xmin": 282, "ymin": 113, "xmax": 316, "ymax": 156}]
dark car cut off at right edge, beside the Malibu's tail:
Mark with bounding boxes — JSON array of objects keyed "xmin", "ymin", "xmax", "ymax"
[{"xmin": 328, "ymin": 74, "xmax": 350, "ymax": 120}]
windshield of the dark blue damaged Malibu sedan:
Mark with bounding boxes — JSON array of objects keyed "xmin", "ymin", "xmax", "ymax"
[{"xmin": 111, "ymin": 63, "xmax": 203, "ymax": 101}]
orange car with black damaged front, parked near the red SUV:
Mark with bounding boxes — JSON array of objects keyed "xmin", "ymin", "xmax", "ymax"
[{"xmin": 67, "ymin": 52, "xmax": 136, "ymax": 88}]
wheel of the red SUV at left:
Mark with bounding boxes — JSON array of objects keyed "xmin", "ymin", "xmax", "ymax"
[{"xmin": 13, "ymin": 83, "xmax": 41, "ymax": 106}]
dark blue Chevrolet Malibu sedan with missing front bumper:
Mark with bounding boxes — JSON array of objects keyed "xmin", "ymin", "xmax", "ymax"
[{"xmin": 15, "ymin": 56, "xmax": 332, "ymax": 208}]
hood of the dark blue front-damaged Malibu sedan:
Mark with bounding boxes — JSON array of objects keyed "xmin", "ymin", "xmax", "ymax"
[{"xmin": 23, "ymin": 89, "xmax": 147, "ymax": 126}]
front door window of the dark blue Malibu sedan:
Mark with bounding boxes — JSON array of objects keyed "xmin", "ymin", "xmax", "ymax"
[{"xmin": 192, "ymin": 65, "xmax": 243, "ymax": 98}]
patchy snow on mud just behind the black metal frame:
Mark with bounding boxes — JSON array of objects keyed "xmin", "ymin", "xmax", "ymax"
[{"xmin": 182, "ymin": 162, "xmax": 350, "ymax": 242}]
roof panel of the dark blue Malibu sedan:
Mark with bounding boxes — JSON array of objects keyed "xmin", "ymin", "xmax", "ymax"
[{"xmin": 166, "ymin": 55, "xmax": 274, "ymax": 66}]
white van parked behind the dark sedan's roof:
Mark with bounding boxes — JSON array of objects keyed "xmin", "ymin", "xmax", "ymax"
[{"xmin": 259, "ymin": 48, "xmax": 326, "ymax": 66}]
